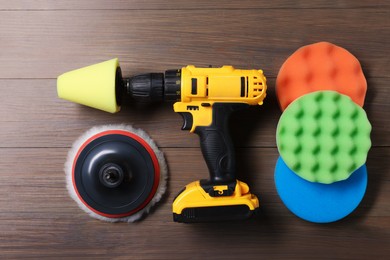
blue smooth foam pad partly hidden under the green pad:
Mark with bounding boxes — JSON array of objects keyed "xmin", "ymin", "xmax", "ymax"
[{"xmin": 275, "ymin": 157, "xmax": 367, "ymax": 223}]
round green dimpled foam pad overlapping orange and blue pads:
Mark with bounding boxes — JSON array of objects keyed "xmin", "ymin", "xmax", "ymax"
[{"xmin": 276, "ymin": 91, "xmax": 371, "ymax": 184}]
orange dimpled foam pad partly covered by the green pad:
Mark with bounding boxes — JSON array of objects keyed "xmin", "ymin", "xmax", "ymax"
[{"xmin": 276, "ymin": 42, "xmax": 367, "ymax": 111}]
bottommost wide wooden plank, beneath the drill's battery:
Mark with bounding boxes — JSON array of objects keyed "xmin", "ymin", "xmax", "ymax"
[{"xmin": 0, "ymin": 148, "xmax": 390, "ymax": 259}]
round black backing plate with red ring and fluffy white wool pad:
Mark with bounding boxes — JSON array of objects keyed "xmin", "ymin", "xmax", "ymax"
[{"xmin": 65, "ymin": 125, "xmax": 167, "ymax": 222}]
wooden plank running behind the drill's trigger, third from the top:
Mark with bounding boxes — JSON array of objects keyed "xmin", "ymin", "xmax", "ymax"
[{"xmin": 0, "ymin": 78, "xmax": 390, "ymax": 147}]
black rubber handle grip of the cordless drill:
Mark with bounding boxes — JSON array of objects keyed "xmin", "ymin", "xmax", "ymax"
[{"xmin": 195, "ymin": 103, "xmax": 248, "ymax": 184}]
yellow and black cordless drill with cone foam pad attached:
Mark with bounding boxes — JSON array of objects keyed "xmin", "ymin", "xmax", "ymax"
[{"xmin": 57, "ymin": 59, "xmax": 267, "ymax": 223}]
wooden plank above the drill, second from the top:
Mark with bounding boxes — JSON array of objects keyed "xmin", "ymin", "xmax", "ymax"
[{"xmin": 0, "ymin": 8, "xmax": 390, "ymax": 78}]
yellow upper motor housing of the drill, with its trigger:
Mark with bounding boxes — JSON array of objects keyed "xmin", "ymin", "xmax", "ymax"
[{"xmin": 173, "ymin": 65, "xmax": 267, "ymax": 132}]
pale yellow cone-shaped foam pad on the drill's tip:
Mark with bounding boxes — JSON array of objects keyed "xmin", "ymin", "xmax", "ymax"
[{"xmin": 57, "ymin": 59, "xmax": 123, "ymax": 113}]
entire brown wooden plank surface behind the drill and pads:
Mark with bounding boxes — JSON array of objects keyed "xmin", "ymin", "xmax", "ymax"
[{"xmin": 0, "ymin": 0, "xmax": 390, "ymax": 259}]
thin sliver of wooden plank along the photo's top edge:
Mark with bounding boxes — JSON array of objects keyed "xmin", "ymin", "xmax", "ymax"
[{"xmin": 0, "ymin": 0, "xmax": 390, "ymax": 10}]
